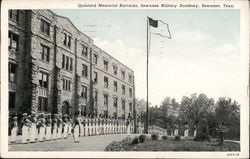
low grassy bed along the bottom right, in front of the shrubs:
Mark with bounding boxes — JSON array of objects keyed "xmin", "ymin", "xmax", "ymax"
[{"xmin": 107, "ymin": 139, "xmax": 240, "ymax": 151}]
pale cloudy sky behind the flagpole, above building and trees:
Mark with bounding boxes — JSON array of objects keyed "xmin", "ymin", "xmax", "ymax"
[{"xmin": 52, "ymin": 9, "xmax": 241, "ymax": 105}]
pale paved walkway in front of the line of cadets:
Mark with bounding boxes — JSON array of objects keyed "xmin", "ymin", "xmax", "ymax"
[{"xmin": 9, "ymin": 134, "xmax": 138, "ymax": 151}]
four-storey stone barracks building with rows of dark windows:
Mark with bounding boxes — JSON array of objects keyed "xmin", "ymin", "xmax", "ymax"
[{"xmin": 8, "ymin": 10, "xmax": 135, "ymax": 117}]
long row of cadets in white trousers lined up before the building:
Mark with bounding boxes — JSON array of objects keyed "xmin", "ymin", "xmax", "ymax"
[{"xmin": 10, "ymin": 113, "xmax": 143, "ymax": 144}]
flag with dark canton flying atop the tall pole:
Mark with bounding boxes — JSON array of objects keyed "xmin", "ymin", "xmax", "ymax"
[{"xmin": 148, "ymin": 17, "xmax": 171, "ymax": 39}]
